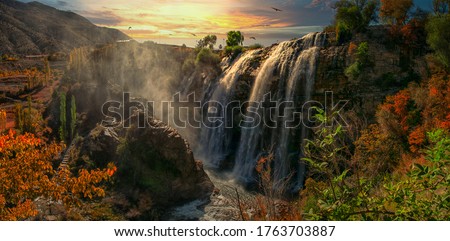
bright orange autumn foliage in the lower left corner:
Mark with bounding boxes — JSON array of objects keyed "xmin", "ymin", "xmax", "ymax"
[{"xmin": 0, "ymin": 130, "xmax": 115, "ymax": 220}]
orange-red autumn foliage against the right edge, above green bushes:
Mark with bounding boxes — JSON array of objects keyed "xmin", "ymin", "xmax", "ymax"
[{"xmin": 377, "ymin": 72, "xmax": 450, "ymax": 154}]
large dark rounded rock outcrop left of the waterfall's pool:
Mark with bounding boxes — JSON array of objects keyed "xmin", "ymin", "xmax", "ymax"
[{"xmin": 72, "ymin": 118, "xmax": 214, "ymax": 220}]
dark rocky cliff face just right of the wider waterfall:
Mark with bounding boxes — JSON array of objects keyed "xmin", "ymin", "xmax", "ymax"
[{"xmin": 314, "ymin": 27, "xmax": 427, "ymax": 119}]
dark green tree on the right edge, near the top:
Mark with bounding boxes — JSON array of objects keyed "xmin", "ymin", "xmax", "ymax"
[{"xmin": 426, "ymin": 14, "xmax": 450, "ymax": 69}]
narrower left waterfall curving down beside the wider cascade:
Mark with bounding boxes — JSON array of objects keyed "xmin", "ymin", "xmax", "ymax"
[{"xmin": 201, "ymin": 50, "xmax": 258, "ymax": 168}]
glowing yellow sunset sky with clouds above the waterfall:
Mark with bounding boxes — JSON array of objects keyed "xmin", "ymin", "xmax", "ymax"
[{"xmin": 23, "ymin": 0, "xmax": 432, "ymax": 45}]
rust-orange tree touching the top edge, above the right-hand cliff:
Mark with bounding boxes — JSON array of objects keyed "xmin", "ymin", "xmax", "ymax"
[{"xmin": 380, "ymin": 0, "xmax": 414, "ymax": 25}]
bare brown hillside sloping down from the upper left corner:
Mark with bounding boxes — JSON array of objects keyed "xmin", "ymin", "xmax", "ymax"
[{"xmin": 0, "ymin": 0, "xmax": 130, "ymax": 54}]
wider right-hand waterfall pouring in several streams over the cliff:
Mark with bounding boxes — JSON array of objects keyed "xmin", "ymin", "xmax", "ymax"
[{"xmin": 234, "ymin": 33, "xmax": 325, "ymax": 185}]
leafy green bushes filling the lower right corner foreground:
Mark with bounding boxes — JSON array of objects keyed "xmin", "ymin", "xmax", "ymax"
[{"xmin": 301, "ymin": 106, "xmax": 450, "ymax": 221}]
